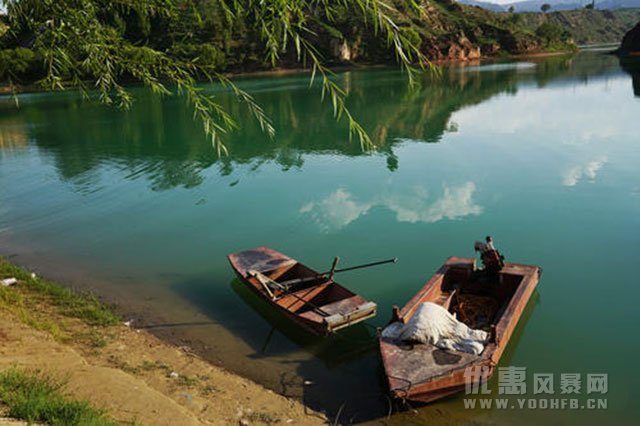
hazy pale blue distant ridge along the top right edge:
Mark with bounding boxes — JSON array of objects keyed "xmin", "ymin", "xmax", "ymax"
[{"xmin": 458, "ymin": 0, "xmax": 640, "ymax": 12}]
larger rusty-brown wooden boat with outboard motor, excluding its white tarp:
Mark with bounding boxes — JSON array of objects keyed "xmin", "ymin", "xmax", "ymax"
[{"xmin": 379, "ymin": 257, "xmax": 541, "ymax": 402}]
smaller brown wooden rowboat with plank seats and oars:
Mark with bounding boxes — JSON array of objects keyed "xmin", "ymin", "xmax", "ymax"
[{"xmin": 227, "ymin": 247, "xmax": 377, "ymax": 335}]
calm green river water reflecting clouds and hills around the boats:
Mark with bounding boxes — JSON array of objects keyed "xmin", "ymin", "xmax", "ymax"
[{"xmin": 0, "ymin": 52, "xmax": 640, "ymax": 424}]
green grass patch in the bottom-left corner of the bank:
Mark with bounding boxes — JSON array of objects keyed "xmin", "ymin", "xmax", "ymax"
[{"xmin": 0, "ymin": 368, "xmax": 118, "ymax": 426}]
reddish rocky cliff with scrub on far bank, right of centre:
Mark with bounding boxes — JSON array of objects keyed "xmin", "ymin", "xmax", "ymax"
[{"xmin": 321, "ymin": 0, "xmax": 573, "ymax": 63}]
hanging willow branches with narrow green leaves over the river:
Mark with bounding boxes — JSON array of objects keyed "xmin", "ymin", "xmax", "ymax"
[{"xmin": 4, "ymin": 0, "xmax": 429, "ymax": 154}]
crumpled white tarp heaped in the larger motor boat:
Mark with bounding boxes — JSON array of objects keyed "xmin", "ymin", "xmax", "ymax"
[{"xmin": 382, "ymin": 302, "xmax": 490, "ymax": 355}]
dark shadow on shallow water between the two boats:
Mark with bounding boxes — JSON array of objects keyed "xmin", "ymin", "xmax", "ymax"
[{"xmin": 230, "ymin": 279, "xmax": 393, "ymax": 424}]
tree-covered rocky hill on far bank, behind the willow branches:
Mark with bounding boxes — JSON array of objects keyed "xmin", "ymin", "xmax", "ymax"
[{"xmin": 0, "ymin": 0, "xmax": 572, "ymax": 83}]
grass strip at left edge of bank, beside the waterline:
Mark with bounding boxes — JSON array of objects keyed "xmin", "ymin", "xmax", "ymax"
[{"xmin": 0, "ymin": 257, "xmax": 121, "ymax": 340}]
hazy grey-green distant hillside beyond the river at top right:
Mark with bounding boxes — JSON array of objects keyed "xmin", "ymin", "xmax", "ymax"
[{"xmin": 520, "ymin": 9, "xmax": 640, "ymax": 45}]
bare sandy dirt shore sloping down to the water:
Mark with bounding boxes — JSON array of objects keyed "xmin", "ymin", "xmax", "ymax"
[{"xmin": 0, "ymin": 259, "xmax": 326, "ymax": 425}]
